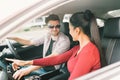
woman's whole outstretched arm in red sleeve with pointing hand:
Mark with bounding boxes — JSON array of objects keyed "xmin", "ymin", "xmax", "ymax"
[{"xmin": 6, "ymin": 47, "xmax": 73, "ymax": 68}]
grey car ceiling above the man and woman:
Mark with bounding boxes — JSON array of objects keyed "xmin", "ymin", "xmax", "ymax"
[{"xmin": 47, "ymin": 0, "xmax": 120, "ymax": 19}]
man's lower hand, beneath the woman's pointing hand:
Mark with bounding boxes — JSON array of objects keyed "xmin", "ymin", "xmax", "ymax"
[{"xmin": 13, "ymin": 68, "xmax": 31, "ymax": 80}]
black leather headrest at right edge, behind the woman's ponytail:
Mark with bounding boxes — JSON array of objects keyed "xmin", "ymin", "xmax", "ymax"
[{"xmin": 103, "ymin": 17, "xmax": 120, "ymax": 38}]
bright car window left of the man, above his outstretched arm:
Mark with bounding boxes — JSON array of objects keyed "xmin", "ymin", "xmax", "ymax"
[{"xmin": 8, "ymin": 16, "xmax": 48, "ymax": 39}]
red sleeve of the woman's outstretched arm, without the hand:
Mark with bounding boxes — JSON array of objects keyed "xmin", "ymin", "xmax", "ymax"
[{"xmin": 33, "ymin": 50, "xmax": 73, "ymax": 66}]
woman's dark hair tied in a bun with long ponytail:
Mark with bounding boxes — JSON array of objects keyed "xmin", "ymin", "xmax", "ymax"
[{"xmin": 70, "ymin": 10, "xmax": 106, "ymax": 66}]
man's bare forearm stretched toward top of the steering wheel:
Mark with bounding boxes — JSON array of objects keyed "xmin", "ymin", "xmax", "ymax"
[{"xmin": 8, "ymin": 37, "xmax": 33, "ymax": 46}]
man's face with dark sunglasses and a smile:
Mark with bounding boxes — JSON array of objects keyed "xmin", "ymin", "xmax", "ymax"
[{"xmin": 48, "ymin": 20, "xmax": 60, "ymax": 36}]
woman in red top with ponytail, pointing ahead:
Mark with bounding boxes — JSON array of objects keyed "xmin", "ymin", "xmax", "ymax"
[{"xmin": 6, "ymin": 10, "xmax": 101, "ymax": 80}]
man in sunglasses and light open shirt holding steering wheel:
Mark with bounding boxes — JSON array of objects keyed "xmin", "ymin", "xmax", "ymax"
[{"xmin": 6, "ymin": 14, "xmax": 70, "ymax": 79}]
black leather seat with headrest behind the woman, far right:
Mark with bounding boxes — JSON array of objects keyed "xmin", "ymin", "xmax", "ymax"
[{"xmin": 102, "ymin": 18, "xmax": 120, "ymax": 65}]
